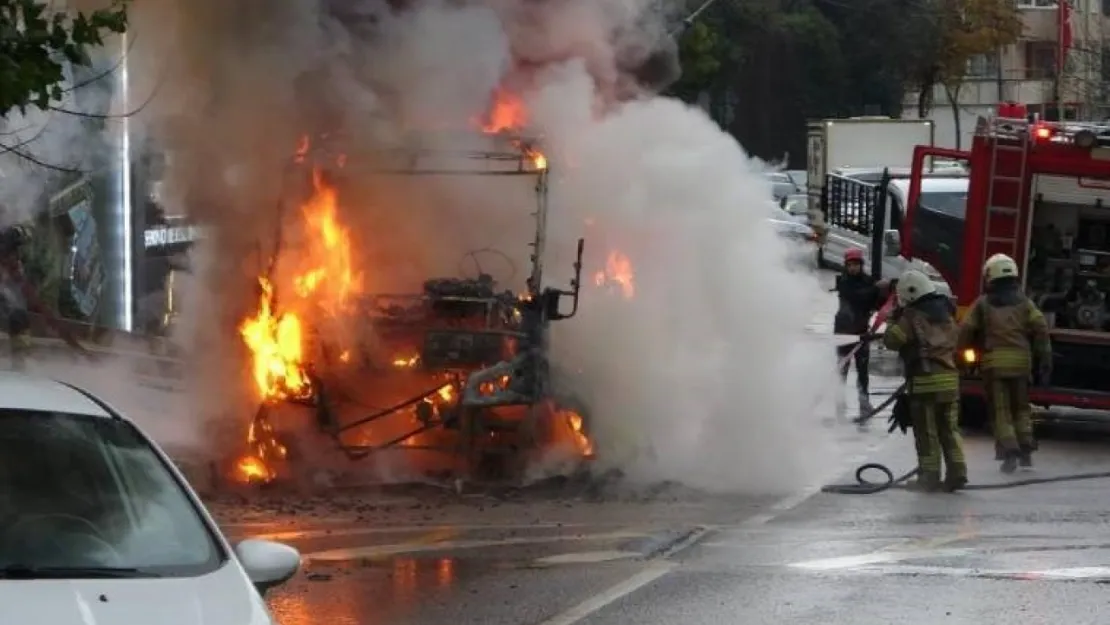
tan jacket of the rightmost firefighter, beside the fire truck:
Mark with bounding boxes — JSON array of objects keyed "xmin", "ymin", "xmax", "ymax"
[{"xmin": 960, "ymin": 281, "xmax": 1052, "ymax": 377}]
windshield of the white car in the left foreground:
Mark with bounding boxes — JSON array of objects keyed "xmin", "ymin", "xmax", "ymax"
[{"xmin": 0, "ymin": 411, "xmax": 228, "ymax": 578}]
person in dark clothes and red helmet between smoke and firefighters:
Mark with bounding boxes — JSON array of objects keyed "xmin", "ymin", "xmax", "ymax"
[{"xmin": 833, "ymin": 248, "xmax": 882, "ymax": 417}]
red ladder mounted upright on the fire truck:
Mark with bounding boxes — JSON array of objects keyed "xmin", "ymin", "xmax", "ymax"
[{"xmin": 982, "ymin": 120, "xmax": 1032, "ymax": 260}]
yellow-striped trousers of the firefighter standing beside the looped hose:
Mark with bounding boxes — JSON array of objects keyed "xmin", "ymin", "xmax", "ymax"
[{"xmin": 909, "ymin": 393, "xmax": 968, "ymax": 484}]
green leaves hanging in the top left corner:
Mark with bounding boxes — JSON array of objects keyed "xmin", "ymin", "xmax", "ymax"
[{"xmin": 0, "ymin": 0, "xmax": 128, "ymax": 115}]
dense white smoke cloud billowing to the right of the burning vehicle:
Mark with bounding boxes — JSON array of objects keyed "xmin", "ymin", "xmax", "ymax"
[{"xmin": 535, "ymin": 69, "xmax": 829, "ymax": 492}]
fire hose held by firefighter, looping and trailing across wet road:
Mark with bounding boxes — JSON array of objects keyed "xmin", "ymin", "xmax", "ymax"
[{"xmin": 821, "ymin": 298, "xmax": 1110, "ymax": 495}]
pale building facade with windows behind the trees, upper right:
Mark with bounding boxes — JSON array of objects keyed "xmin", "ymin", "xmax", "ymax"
[{"xmin": 905, "ymin": 0, "xmax": 1110, "ymax": 148}]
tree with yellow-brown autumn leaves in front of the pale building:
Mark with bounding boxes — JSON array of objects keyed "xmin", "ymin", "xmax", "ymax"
[{"xmin": 919, "ymin": 0, "xmax": 1025, "ymax": 149}]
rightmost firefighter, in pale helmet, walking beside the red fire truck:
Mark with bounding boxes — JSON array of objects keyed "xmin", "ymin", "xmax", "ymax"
[{"xmin": 960, "ymin": 254, "xmax": 1052, "ymax": 473}]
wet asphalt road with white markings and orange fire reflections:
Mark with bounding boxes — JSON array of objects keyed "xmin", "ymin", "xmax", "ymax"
[{"xmin": 204, "ymin": 269, "xmax": 1110, "ymax": 625}]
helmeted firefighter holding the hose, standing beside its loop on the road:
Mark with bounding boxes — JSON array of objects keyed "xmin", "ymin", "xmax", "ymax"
[{"xmin": 882, "ymin": 270, "xmax": 968, "ymax": 491}]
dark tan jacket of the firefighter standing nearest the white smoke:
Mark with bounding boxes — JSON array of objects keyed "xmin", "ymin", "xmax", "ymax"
[{"xmin": 882, "ymin": 294, "xmax": 960, "ymax": 399}]
